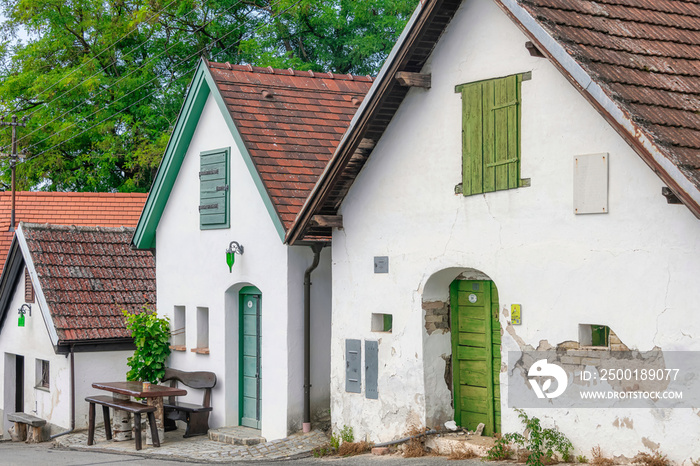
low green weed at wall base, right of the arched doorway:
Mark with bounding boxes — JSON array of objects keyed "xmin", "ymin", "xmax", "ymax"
[{"xmin": 503, "ymin": 409, "xmax": 574, "ymax": 466}]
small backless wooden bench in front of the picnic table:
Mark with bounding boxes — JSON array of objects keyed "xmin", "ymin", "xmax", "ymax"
[{"xmin": 85, "ymin": 395, "xmax": 160, "ymax": 450}]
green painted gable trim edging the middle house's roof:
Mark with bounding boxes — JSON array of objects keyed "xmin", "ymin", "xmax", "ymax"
[{"xmin": 131, "ymin": 60, "xmax": 285, "ymax": 249}]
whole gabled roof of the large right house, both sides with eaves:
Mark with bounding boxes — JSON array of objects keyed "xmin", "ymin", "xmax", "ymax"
[{"xmin": 286, "ymin": 0, "xmax": 700, "ymax": 244}]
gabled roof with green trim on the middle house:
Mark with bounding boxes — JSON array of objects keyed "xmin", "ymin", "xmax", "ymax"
[{"xmin": 133, "ymin": 61, "xmax": 372, "ymax": 249}]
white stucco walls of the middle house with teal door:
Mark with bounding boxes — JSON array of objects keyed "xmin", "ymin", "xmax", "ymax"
[{"xmin": 156, "ymin": 95, "xmax": 330, "ymax": 440}]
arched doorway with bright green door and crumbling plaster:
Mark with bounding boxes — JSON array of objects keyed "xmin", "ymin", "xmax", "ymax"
[{"xmin": 422, "ymin": 267, "xmax": 501, "ymax": 435}]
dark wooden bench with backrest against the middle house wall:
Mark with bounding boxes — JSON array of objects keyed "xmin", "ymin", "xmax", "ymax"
[{"xmin": 163, "ymin": 368, "xmax": 216, "ymax": 438}]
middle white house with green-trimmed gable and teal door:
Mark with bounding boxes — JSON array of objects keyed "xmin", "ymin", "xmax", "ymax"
[{"xmin": 133, "ymin": 61, "xmax": 371, "ymax": 440}]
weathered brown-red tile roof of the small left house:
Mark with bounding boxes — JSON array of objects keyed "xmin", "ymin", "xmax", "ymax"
[{"xmin": 21, "ymin": 222, "xmax": 156, "ymax": 343}]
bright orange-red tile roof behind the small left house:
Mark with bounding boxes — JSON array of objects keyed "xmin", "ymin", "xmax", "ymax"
[{"xmin": 0, "ymin": 191, "xmax": 148, "ymax": 271}]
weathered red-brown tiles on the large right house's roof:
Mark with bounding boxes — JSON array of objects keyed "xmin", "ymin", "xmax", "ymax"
[{"xmin": 519, "ymin": 0, "xmax": 700, "ymax": 189}]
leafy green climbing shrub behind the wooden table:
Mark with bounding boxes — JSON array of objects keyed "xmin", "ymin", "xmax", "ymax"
[{"xmin": 123, "ymin": 307, "xmax": 170, "ymax": 383}]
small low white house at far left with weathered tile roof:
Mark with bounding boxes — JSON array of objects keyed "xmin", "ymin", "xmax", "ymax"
[{"xmin": 0, "ymin": 223, "xmax": 155, "ymax": 435}]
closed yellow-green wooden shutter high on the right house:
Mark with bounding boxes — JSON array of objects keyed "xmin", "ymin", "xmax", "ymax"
[{"xmin": 457, "ymin": 75, "xmax": 522, "ymax": 196}]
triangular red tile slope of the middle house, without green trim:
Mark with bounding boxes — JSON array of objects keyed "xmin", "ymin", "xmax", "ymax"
[{"xmin": 209, "ymin": 62, "xmax": 372, "ymax": 230}]
